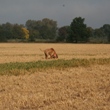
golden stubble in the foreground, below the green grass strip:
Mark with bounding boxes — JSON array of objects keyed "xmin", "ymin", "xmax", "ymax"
[{"xmin": 0, "ymin": 65, "xmax": 110, "ymax": 110}]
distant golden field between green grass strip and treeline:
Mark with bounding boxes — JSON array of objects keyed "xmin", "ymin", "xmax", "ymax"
[{"xmin": 0, "ymin": 43, "xmax": 110, "ymax": 63}]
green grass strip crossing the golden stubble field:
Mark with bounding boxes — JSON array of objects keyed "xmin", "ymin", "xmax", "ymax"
[{"xmin": 0, "ymin": 58, "xmax": 110, "ymax": 75}]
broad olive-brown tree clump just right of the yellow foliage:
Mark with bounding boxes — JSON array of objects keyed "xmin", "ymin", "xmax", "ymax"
[{"xmin": 26, "ymin": 18, "xmax": 57, "ymax": 39}]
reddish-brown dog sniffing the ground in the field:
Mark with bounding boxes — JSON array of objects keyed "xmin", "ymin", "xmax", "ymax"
[{"xmin": 40, "ymin": 48, "xmax": 58, "ymax": 59}]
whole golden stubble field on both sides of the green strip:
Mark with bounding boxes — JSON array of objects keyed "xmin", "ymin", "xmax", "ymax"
[{"xmin": 0, "ymin": 43, "xmax": 110, "ymax": 110}]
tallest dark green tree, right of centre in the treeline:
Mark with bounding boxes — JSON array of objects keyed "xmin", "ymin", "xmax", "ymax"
[{"xmin": 68, "ymin": 17, "xmax": 89, "ymax": 43}]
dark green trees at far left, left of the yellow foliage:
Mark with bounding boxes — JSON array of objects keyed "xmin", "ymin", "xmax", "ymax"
[{"xmin": 0, "ymin": 23, "xmax": 25, "ymax": 42}]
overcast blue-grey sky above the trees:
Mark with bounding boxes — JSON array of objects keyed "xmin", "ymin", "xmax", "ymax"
[{"xmin": 0, "ymin": 0, "xmax": 110, "ymax": 28}]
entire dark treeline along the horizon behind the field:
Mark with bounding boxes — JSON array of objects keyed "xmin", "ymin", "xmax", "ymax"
[{"xmin": 0, "ymin": 17, "xmax": 110, "ymax": 43}]
